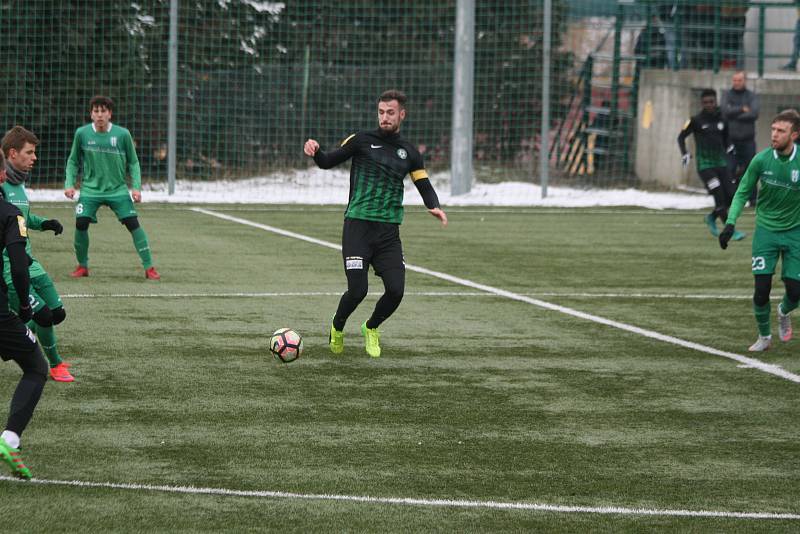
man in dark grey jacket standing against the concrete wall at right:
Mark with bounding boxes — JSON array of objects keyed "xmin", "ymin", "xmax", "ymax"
[{"xmin": 720, "ymin": 71, "xmax": 759, "ymax": 206}]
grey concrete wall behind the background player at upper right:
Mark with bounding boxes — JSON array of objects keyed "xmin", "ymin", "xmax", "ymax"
[{"xmin": 635, "ymin": 70, "xmax": 800, "ymax": 189}]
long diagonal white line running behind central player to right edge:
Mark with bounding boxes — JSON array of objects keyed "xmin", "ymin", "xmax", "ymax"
[{"xmin": 192, "ymin": 208, "xmax": 800, "ymax": 384}]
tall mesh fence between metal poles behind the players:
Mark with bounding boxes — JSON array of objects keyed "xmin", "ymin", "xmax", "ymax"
[{"xmin": 0, "ymin": 0, "xmax": 794, "ymax": 194}]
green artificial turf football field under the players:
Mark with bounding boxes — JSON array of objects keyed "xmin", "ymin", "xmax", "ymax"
[{"xmin": 0, "ymin": 203, "xmax": 800, "ymax": 532}]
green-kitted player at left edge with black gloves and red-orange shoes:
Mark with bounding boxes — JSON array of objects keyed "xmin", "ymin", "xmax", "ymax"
[{"xmin": 0, "ymin": 126, "xmax": 74, "ymax": 382}]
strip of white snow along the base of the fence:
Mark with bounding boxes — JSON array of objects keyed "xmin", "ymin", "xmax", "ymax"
[{"xmin": 28, "ymin": 169, "xmax": 713, "ymax": 209}]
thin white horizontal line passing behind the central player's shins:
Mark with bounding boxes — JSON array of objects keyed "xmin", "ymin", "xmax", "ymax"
[{"xmin": 60, "ymin": 289, "xmax": 760, "ymax": 301}]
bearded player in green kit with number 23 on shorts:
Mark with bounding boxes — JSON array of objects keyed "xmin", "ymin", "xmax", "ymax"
[{"xmin": 719, "ymin": 109, "xmax": 800, "ymax": 352}]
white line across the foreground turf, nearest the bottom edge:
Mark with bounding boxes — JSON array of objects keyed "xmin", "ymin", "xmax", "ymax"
[{"xmin": 0, "ymin": 476, "xmax": 800, "ymax": 520}]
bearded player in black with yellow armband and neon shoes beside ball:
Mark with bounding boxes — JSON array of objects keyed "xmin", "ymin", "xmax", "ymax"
[{"xmin": 303, "ymin": 90, "xmax": 447, "ymax": 358}]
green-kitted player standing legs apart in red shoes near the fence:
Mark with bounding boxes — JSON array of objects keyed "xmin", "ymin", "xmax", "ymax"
[{"xmin": 64, "ymin": 96, "xmax": 161, "ymax": 280}]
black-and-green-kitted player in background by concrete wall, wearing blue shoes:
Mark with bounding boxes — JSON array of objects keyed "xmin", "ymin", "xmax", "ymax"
[{"xmin": 678, "ymin": 89, "xmax": 745, "ymax": 241}]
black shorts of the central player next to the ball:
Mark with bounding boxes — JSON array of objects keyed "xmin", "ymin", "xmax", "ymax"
[{"xmin": 342, "ymin": 219, "xmax": 406, "ymax": 276}]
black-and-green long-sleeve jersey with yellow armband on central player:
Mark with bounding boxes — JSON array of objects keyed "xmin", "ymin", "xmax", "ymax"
[{"xmin": 314, "ymin": 129, "xmax": 439, "ymax": 224}]
